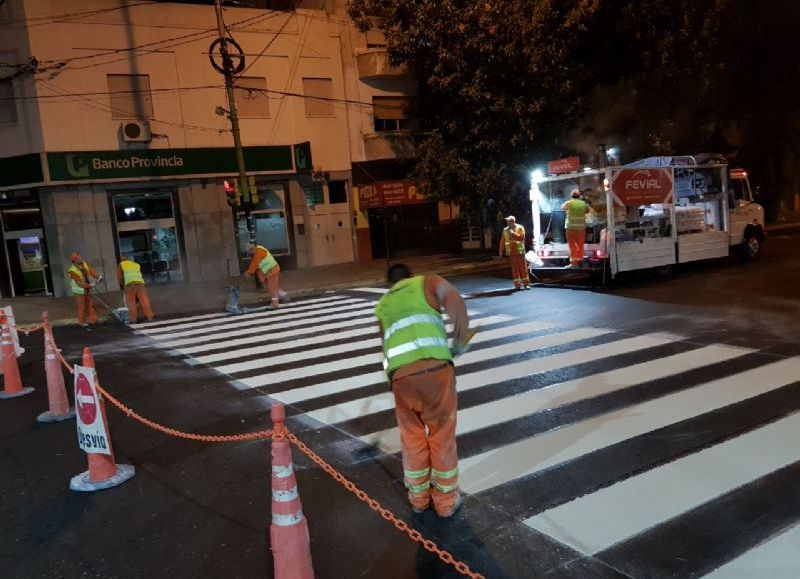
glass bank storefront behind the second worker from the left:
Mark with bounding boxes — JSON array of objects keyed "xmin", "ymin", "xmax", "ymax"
[{"xmin": 112, "ymin": 191, "xmax": 183, "ymax": 283}]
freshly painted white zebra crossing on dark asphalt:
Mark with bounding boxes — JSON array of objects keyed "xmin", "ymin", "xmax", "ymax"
[{"xmin": 133, "ymin": 288, "xmax": 800, "ymax": 579}]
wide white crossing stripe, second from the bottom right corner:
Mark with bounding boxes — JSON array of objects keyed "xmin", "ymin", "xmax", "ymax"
[{"xmin": 525, "ymin": 408, "xmax": 800, "ymax": 552}]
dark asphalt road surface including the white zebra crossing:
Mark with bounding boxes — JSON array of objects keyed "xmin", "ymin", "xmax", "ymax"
[{"xmin": 0, "ymin": 232, "xmax": 800, "ymax": 579}]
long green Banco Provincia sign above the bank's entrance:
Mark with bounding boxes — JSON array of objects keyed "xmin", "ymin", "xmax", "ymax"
[{"xmin": 46, "ymin": 145, "xmax": 295, "ymax": 183}]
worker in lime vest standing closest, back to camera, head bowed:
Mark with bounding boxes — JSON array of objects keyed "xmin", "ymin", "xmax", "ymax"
[{"xmin": 375, "ymin": 264, "xmax": 469, "ymax": 517}]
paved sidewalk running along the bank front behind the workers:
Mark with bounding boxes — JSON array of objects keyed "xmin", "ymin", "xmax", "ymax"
[{"xmin": 6, "ymin": 250, "xmax": 506, "ymax": 326}]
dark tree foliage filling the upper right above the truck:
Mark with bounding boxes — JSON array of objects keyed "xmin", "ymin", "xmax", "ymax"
[{"xmin": 349, "ymin": 0, "xmax": 800, "ymax": 220}]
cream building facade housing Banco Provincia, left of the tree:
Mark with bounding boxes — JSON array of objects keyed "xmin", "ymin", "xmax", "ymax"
[{"xmin": 0, "ymin": 0, "xmax": 457, "ymax": 296}]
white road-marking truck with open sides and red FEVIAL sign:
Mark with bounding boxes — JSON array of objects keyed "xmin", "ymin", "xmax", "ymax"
[{"xmin": 526, "ymin": 154, "xmax": 765, "ymax": 285}]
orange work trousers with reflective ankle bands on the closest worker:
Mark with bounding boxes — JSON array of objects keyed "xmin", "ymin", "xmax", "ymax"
[{"xmin": 392, "ymin": 360, "xmax": 459, "ymax": 516}]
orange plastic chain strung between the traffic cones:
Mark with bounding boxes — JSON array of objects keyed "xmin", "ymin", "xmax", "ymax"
[{"xmin": 50, "ymin": 332, "xmax": 486, "ymax": 579}]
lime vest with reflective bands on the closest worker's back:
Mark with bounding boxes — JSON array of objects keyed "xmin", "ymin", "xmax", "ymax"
[{"xmin": 375, "ymin": 276, "xmax": 453, "ymax": 376}]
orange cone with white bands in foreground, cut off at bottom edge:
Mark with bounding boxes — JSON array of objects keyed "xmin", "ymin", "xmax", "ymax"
[{"xmin": 269, "ymin": 404, "xmax": 314, "ymax": 579}]
